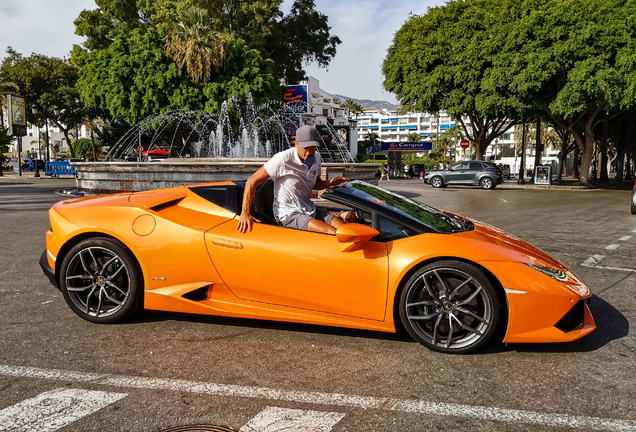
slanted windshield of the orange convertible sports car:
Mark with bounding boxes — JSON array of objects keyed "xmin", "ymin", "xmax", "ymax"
[{"xmin": 342, "ymin": 181, "xmax": 467, "ymax": 233}]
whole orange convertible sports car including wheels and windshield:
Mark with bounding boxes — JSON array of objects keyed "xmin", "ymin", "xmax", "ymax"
[{"xmin": 40, "ymin": 180, "xmax": 596, "ymax": 353}]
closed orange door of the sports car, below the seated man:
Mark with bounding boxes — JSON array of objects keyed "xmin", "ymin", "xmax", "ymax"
[{"xmin": 205, "ymin": 220, "xmax": 388, "ymax": 321}]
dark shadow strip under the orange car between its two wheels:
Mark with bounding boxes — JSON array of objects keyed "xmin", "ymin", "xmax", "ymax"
[{"xmin": 126, "ymin": 311, "xmax": 416, "ymax": 343}]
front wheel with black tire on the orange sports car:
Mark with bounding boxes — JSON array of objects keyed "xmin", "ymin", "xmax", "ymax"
[{"xmin": 399, "ymin": 260, "xmax": 502, "ymax": 354}]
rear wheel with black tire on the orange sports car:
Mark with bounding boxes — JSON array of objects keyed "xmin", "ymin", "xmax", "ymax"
[{"xmin": 60, "ymin": 237, "xmax": 144, "ymax": 324}]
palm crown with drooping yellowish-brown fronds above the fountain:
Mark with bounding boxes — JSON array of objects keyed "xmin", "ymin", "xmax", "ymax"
[{"xmin": 166, "ymin": 6, "xmax": 225, "ymax": 83}]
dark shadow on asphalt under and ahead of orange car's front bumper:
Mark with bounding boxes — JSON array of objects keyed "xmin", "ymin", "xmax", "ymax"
[{"xmin": 482, "ymin": 296, "xmax": 629, "ymax": 353}]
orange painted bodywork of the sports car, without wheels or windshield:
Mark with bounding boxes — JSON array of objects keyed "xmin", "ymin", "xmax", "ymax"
[{"xmin": 46, "ymin": 182, "xmax": 595, "ymax": 342}]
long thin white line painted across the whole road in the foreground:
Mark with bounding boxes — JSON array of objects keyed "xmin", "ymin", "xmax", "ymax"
[{"xmin": 0, "ymin": 365, "xmax": 636, "ymax": 431}]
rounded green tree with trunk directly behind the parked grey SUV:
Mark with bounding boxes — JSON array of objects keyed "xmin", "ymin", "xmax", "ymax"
[{"xmin": 382, "ymin": 0, "xmax": 527, "ymax": 160}]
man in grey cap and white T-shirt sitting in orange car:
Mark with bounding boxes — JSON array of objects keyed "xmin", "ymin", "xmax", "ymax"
[{"xmin": 236, "ymin": 126, "xmax": 355, "ymax": 234}]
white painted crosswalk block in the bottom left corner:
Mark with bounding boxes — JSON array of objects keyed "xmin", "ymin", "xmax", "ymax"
[{"xmin": 0, "ymin": 389, "xmax": 127, "ymax": 432}]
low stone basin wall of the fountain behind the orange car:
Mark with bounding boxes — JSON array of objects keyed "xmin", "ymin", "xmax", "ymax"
[{"xmin": 73, "ymin": 158, "xmax": 378, "ymax": 193}]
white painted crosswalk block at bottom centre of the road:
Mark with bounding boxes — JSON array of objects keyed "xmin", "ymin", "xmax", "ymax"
[{"xmin": 240, "ymin": 407, "xmax": 345, "ymax": 432}]
